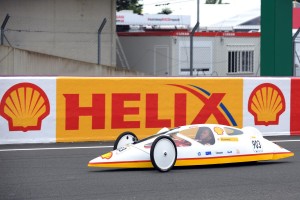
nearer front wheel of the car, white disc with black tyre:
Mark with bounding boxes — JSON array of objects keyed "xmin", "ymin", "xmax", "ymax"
[{"xmin": 150, "ymin": 135, "xmax": 177, "ymax": 172}]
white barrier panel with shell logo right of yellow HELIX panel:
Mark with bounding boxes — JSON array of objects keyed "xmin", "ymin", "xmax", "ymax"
[{"xmin": 243, "ymin": 78, "xmax": 291, "ymax": 135}]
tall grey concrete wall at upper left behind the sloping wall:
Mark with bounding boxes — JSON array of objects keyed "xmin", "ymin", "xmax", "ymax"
[{"xmin": 0, "ymin": 0, "xmax": 116, "ymax": 66}]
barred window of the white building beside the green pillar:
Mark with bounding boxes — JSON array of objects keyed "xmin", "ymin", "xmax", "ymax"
[{"xmin": 228, "ymin": 50, "xmax": 254, "ymax": 73}]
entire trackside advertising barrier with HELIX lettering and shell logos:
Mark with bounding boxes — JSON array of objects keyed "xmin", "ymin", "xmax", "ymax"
[{"xmin": 0, "ymin": 77, "xmax": 300, "ymax": 144}]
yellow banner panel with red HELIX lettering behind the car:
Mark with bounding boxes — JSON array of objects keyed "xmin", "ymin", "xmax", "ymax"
[{"xmin": 56, "ymin": 77, "xmax": 243, "ymax": 142}]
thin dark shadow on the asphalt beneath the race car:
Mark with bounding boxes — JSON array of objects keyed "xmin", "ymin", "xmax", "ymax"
[{"xmin": 89, "ymin": 161, "xmax": 290, "ymax": 173}]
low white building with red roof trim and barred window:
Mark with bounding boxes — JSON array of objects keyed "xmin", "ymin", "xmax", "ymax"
[{"xmin": 118, "ymin": 31, "xmax": 260, "ymax": 76}]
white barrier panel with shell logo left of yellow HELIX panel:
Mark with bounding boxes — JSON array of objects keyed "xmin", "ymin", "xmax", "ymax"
[{"xmin": 0, "ymin": 77, "xmax": 56, "ymax": 144}]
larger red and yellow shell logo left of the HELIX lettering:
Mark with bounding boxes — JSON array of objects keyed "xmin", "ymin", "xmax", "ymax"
[{"xmin": 0, "ymin": 83, "xmax": 50, "ymax": 132}]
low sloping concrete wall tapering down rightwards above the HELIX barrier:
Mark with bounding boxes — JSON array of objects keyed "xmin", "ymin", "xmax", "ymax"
[{"xmin": 0, "ymin": 46, "xmax": 143, "ymax": 77}]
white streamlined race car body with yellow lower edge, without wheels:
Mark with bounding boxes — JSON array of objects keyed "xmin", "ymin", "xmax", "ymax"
[{"xmin": 88, "ymin": 124, "xmax": 294, "ymax": 168}]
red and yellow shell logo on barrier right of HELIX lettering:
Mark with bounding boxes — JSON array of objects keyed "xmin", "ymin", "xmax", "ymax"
[{"xmin": 248, "ymin": 83, "xmax": 285, "ymax": 126}]
